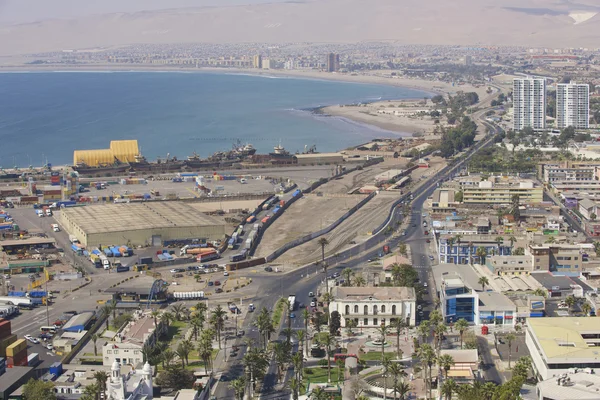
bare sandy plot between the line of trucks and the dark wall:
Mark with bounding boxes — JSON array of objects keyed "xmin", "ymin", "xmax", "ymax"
[{"xmin": 255, "ymin": 194, "xmax": 365, "ymax": 257}]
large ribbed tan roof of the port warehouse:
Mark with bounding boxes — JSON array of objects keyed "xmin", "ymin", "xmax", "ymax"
[{"xmin": 62, "ymin": 201, "xmax": 223, "ymax": 234}]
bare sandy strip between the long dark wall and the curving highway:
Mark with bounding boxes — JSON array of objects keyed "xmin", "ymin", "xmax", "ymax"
[{"xmin": 277, "ymin": 192, "xmax": 399, "ymax": 264}]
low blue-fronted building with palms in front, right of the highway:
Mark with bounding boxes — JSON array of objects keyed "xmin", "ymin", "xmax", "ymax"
[{"xmin": 438, "ymin": 235, "xmax": 511, "ymax": 264}]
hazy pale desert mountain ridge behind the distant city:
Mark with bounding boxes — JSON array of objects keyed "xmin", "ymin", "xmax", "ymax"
[{"xmin": 0, "ymin": 0, "xmax": 600, "ymax": 55}]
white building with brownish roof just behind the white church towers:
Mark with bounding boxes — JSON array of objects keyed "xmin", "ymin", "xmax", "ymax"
[{"xmin": 102, "ymin": 311, "xmax": 165, "ymax": 366}]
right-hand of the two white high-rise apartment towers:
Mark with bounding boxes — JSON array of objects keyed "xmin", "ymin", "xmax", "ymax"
[{"xmin": 556, "ymin": 82, "xmax": 590, "ymax": 129}]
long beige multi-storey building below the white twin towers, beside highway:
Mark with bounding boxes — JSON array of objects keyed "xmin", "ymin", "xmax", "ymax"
[{"xmin": 463, "ymin": 176, "xmax": 544, "ymax": 205}]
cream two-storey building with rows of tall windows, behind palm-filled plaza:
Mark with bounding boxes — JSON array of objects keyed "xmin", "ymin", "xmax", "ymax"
[{"xmin": 329, "ymin": 286, "xmax": 417, "ymax": 328}]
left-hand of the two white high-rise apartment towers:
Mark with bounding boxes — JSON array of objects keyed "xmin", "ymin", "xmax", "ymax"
[{"xmin": 513, "ymin": 78, "xmax": 546, "ymax": 131}]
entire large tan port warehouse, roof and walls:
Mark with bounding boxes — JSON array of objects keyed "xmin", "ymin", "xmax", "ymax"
[{"xmin": 60, "ymin": 201, "xmax": 226, "ymax": 248}]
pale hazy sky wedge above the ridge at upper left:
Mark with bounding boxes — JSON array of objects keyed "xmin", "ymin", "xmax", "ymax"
[{"xmin": 0, "ymin": 0, "xmax": 300, "ymax": 23}]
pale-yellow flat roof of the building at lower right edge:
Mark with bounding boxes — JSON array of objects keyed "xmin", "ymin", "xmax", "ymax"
[{"xmin": 527, "ymin": 317, "xmax": 600, "ymax": 362}]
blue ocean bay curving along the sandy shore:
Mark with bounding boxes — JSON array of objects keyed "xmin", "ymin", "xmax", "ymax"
[{"xmin": 0, "ymin": 72, "xmax": 428, "ymax": 168}]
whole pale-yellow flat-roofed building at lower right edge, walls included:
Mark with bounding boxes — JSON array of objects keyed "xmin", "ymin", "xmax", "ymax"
[{"xmin": 525, "ymin": 317, "xmax": 600, "ymax": 380}]
